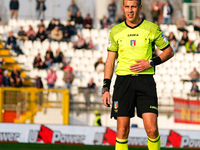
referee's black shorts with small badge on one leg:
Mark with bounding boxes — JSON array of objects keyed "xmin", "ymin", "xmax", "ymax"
[{"xmin": 111, "ymin": 75, "xmax": 158, "ymax": 119}]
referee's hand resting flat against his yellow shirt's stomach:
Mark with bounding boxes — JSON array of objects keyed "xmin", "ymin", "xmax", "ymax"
[{"xmin": 130, "ymin": 59, "xmax": 151, "ymax": 72}]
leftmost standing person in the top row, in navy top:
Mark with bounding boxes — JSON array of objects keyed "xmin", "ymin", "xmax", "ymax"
[{"xmin": 10, "ymin": 0, "xmax": 19, "ymax": 20}]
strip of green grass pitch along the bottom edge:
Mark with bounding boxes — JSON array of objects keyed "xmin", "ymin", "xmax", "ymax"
[{"xmin": 0, "ymin": 143, "xmax": 195, "ymax": 150}]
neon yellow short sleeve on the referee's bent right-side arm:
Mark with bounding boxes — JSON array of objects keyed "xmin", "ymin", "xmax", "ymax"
[{"xmin": 155, "ymin": 26, "xmax": 169, "ymax": 50}]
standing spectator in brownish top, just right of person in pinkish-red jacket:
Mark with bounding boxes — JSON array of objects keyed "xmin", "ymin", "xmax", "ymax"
[{"xmin": 63, "ymin": 62, "xmax": 74, "ymax": 90}]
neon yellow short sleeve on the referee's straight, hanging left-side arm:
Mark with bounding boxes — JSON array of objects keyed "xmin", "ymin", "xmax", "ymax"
[{"xmin": 107, "ymin": 30, "xmax": 118, "ymax": 52}]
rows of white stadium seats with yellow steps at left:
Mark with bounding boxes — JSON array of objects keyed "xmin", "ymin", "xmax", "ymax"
[{"xmin": 0, "ymin": 17, "xmax": 200, "ymax": 124}]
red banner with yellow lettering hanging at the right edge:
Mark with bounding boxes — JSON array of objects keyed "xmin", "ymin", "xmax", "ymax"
[{"xmin": 173, "ymin": 97, "xmax": 200, "ymax": 124}]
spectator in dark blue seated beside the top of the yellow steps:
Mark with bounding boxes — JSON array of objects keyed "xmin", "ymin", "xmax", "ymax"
[{"xmin": 4, "ymin": 31, "xmax": 24, "ymax": 55}]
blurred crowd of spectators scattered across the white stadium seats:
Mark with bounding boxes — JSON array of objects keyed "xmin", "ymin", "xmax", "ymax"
[{"xmin": 0, "ymin": 0, "xmax": 200, "ymax": 97}]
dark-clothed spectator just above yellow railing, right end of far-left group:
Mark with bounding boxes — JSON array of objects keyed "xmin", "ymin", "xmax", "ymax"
[{"xmin": 10, "ymin": 67, "xmax": 24, "ymax": 87}]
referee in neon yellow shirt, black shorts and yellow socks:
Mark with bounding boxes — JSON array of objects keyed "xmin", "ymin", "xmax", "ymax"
[{"xmin": 102, "ymin": 0, "xmax": 174, "ymax": 150}]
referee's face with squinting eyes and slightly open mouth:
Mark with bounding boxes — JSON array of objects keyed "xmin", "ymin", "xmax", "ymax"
[{"xmin": 123, "ymin": 0, "xmax": 142, "ymax": 24}]
